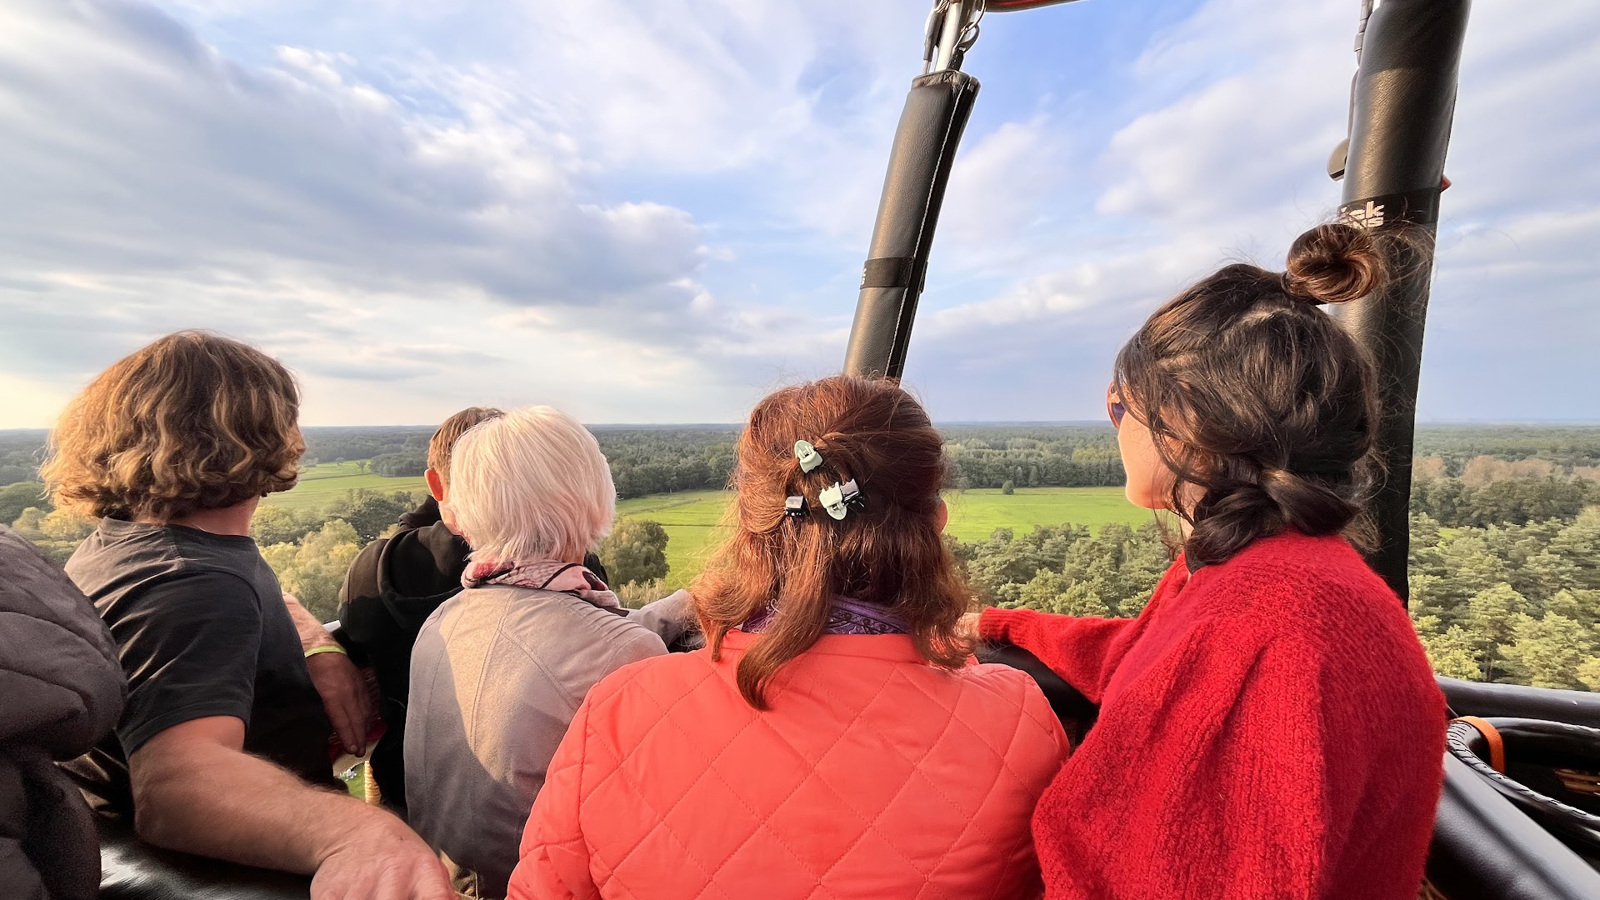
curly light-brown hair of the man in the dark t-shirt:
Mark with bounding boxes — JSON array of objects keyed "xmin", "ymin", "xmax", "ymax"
[{"xmin": 40, "ymin": 331, "xmax": 306, "ymax": 522}]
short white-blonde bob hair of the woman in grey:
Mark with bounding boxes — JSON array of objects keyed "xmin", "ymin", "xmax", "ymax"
[{"xmin": 450, "ymin": 407, "xmax": 616, "ymax": 565}]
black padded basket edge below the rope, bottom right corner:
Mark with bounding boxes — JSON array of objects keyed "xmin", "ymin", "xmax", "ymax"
[{"xmin": 1427, "ymin": 753, "xmax": 1600, "ymax": 900}]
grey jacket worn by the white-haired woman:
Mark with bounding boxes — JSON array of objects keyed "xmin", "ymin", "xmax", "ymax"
[{"xmin": 405, "ymin": 585, "xmax": 690, "ymax": 897}]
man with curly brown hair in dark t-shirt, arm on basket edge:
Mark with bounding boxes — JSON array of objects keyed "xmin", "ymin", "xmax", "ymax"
[{"xmin": 42, "ymin": 331, "xmax": 451, "ymax": 900}]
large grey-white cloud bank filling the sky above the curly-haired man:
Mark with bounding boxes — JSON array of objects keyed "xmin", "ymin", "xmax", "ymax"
[{"xmin": 0, "ymin": 2, "xmax": 793, "ymax": 423}]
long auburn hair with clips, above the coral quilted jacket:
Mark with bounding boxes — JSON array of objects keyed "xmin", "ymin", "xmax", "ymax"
[{"xmin": 690, "ymin": 376, "xmax": 973, "ymax": 709}]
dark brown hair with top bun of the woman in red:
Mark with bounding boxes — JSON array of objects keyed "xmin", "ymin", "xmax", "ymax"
[{"xmin": 1114, "ymin": 224, "xmax": 1387, "ymax": 570}]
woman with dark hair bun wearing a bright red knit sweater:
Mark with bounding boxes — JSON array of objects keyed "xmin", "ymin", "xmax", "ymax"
[{"xmin": 979, "ymin": 224, "xmax": 1445, "ymax": 900}]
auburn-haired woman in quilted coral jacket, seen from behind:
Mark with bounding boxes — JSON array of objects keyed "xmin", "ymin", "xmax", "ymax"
[{"xmin": 510, "ymin": 376, "xmax": 1067, "ymax": 900}]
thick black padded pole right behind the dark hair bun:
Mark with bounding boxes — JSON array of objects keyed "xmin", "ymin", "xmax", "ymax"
[{"xmin": 1334, "ymin": 0, "xmax": 1470, "ymax": 599}]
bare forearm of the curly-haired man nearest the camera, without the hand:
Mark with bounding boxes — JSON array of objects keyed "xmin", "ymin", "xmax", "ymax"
[{"xmin": 134, "ymin": 736, "xmax": 393, "ymax": 874}]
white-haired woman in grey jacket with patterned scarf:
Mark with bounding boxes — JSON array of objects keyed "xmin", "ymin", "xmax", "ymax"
[{"xmin": 405, "ymin": 407, "xmax": 688, "ymax": 897}]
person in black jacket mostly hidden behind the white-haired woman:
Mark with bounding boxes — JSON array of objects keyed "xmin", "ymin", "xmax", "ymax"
[{"xmin": 339, "ymin": 407, "xmax": 606, "ymax": 810}]
